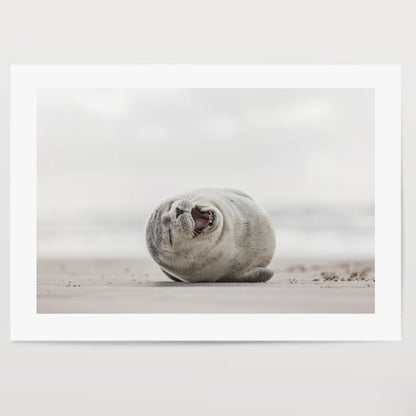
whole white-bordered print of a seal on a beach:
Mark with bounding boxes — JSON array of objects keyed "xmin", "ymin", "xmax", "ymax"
[{"xmin": 11, "ymin": 65, "xmax": 401, "ymax": 341}]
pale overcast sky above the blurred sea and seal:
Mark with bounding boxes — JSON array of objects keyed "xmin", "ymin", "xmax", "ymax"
[{"xmin": 38, "ymin": 89, "xmax": 374, "ymax": 223}]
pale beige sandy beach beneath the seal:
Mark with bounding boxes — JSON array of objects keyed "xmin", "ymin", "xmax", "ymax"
[{"xmin": 37, "ymin": 259, "xmax": 375, "ymax": 313}]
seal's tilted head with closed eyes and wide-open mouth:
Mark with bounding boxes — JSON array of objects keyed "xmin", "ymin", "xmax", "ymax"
[{"xmin": 146, "ymin": 197, "xmax": 223, "ymax": 266}]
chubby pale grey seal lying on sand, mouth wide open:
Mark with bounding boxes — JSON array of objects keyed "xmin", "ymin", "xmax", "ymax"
[{"xmin": 146, "ymin": 188, "xmax": 276, "ymax": 283}]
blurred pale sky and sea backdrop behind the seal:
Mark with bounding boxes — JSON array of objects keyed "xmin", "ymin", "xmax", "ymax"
[{"xmin": 38, "ymin": 89, "xmax": 374, "ymax": 260}]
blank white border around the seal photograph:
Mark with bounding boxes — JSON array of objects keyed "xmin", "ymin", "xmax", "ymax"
[{"xmin": 10, "ymin": 65, "xmax": 401, "ymax": 341}]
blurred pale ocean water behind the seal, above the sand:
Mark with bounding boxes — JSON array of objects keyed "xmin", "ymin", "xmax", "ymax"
[{"xmin": 38, "ymin": 206, "xmax": 374, "ymax": 260}]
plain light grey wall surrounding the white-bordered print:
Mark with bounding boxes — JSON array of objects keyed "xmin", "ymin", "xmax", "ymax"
[{"xmin": 0, "ymin": 0, "xmax": 416, "ymax": 416}]
